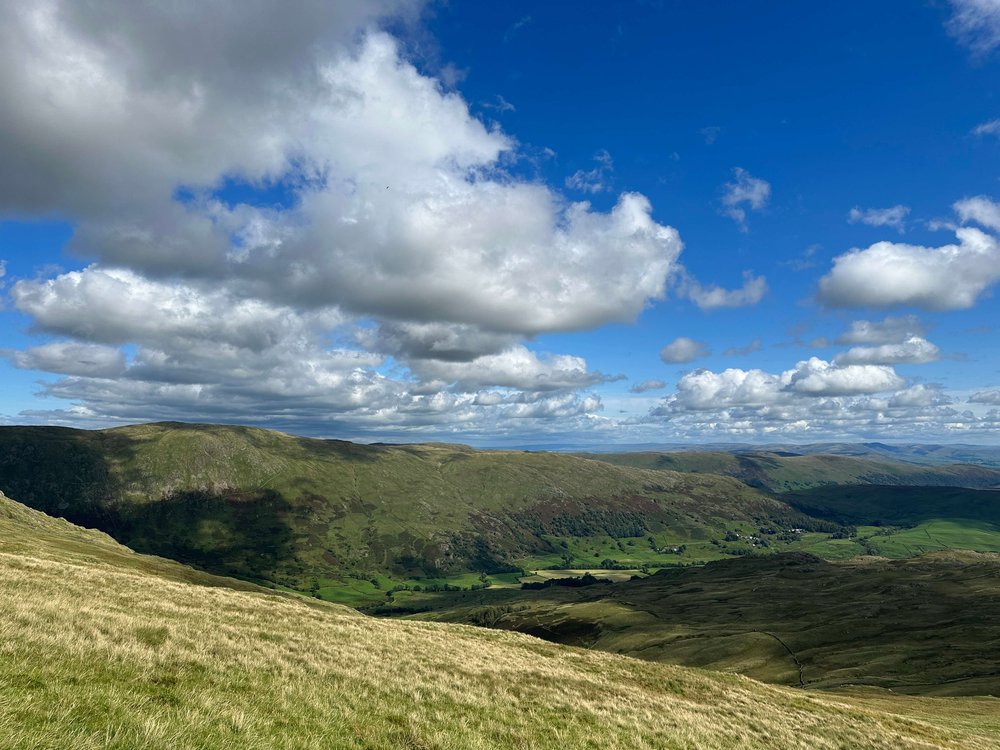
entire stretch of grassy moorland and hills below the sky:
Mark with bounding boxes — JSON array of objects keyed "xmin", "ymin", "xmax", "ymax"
[{"xmin": 0, "ymin": 423, "xmax": 1000, "ymax": 748}]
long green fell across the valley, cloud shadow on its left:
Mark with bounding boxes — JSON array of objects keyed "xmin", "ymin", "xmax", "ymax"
[{"xmin": 0, "ymin": 424, "xmax": 807, "ymax": 600}]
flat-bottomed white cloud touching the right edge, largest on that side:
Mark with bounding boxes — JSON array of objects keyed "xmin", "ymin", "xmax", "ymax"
[{"xmin": 819, "ymin": 227, "xmax": 1000, "ymax": 310}]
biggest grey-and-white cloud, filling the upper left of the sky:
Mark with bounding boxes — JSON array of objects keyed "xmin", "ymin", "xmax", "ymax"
[{"xmin": 0, "ymin": 3, "xmax": 681, "ymax": 335}]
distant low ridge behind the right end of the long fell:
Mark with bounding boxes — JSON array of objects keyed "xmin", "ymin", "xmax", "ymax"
[{"xmin": 581, "ymin": 451, "xmax": 1000, "ymax": 492}]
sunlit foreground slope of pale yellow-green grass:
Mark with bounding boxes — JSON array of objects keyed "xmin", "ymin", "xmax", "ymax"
[{"xmin": 0, "ymin": 494, "xmax": 1000, "ymax": 750}]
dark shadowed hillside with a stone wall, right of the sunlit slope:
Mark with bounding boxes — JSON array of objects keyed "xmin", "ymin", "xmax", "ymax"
[{"xmin": 392, "ymin": 552, "xmax": 1000, "ymax": 700}]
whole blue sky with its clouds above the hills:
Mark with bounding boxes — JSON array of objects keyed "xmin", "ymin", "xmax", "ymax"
[{"xmin": 0, "ymin": 0, "xmax": 1000, "ymax": 445}]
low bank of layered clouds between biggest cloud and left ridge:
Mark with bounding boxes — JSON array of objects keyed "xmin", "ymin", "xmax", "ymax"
[{"xmin": 3, "ymin": 268, "xmax": 613, "ymax": 429}]
